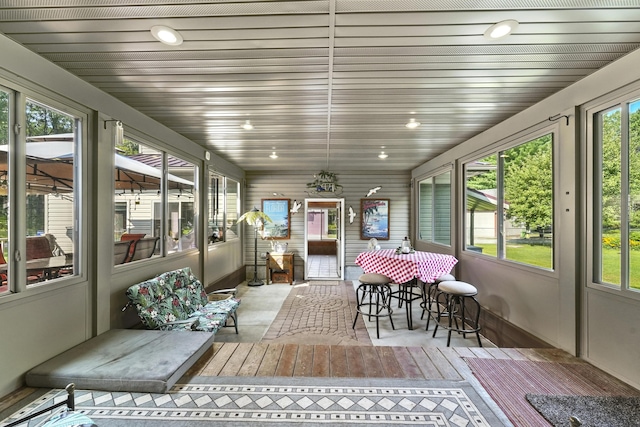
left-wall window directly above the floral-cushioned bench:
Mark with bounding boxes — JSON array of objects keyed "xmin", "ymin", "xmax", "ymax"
[{"xmin": 114, "ymin": 137, "xmax": 198, "ymax": 264}]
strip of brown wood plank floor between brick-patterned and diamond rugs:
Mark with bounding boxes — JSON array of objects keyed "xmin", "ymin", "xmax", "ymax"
[{"xmin": 186, "ymin": 343, "xmax": 585, "ymax": 380}]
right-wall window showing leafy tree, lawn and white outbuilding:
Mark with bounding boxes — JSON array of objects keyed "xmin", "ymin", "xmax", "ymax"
[{"xmin": 464, "ymin": 133, "xmax": 554, "ymax": 269}]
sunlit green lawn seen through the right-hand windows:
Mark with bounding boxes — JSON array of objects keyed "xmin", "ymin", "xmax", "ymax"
[{"xmin": 476, "ymin": 244, "xmax": 640, "ymax": 289}]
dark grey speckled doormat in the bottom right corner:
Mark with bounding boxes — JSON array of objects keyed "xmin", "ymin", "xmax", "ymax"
[{"xmin": 526, "ymin": 394, "xmax": 640, "ymax": 427}]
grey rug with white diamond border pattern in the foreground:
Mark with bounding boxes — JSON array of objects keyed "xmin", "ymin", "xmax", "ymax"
[{"xmin": 2, "ymin": 377, "xmax": 503, "ymax": 427}]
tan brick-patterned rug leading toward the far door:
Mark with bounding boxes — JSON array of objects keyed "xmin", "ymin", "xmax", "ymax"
[{"xmin": 262, "ymin": 281, "xmax": 371, "ymax": 345}]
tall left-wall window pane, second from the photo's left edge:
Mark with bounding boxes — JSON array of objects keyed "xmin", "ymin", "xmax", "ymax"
[{"xmin": 24, "ymin": 100, "xmax": 81, "ymax": 285}]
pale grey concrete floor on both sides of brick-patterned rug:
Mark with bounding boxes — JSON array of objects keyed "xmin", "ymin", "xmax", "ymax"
[{"xmin": 216, "ymin": 280, "xmax": 495, "ymax": 347}]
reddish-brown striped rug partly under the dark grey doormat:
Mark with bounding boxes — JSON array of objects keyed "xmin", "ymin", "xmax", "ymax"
[{"xmin": 465, "ymin": 358, "xmax": 640, "ymax": 427}]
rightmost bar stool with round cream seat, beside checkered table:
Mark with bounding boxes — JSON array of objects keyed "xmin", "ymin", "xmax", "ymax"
[{"xmin": 433, "ymin": 280, "xmax": 482, "ymax": 347}]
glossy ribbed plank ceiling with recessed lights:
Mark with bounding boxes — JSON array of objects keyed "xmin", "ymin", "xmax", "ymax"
[{"xmin": 0, "ymin": 0, "xmax": 640, "ymax": 172}]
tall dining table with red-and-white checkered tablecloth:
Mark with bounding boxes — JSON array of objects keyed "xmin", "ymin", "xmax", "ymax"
[{"xmin": 356, "ymin": 249, "xmax": 458, "ymax": 329}]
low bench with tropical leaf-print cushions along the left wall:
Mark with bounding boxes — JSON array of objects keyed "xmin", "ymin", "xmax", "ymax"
[{"xmin": 125, "ymin": 267, "xmax": 240, "ymax": 333}]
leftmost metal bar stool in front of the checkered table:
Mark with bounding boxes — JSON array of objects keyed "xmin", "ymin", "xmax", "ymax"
[{"xmin": 352, "ymin": 273, "xmax": 395, "ymax": 338}]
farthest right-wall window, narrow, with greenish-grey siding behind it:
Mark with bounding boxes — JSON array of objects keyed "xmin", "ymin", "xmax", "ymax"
[{"xmin": 418, "ymin": 171, "xmax": 451, "ymax": 246}]
